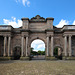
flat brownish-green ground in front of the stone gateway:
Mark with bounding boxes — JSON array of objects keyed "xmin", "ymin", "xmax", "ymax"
[{"xmin": 0, "ymin": 60, "xmax": 75, "ymax": 75}]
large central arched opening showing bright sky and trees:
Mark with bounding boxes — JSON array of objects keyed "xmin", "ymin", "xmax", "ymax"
[{"xmin": 30, "ymin": 39, "xmax": 45, "ymax": 60}]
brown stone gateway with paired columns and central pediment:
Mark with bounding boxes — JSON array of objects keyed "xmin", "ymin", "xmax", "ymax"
[{"xmin": 0, "ymin": 15, "xmax": 75, "ymax": 60}]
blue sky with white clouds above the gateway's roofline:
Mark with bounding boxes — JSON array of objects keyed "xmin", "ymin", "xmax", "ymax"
[{"xmin": 0, "ymin": 0, "xmax": 75, "ymax": 51}]
